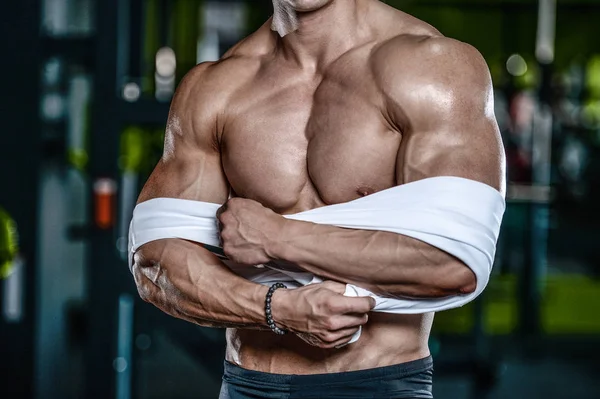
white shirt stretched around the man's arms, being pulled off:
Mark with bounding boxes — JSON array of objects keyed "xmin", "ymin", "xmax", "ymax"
[{"xmin": 129, "ymin": 177, "xmax": 505, "ymax": 339}]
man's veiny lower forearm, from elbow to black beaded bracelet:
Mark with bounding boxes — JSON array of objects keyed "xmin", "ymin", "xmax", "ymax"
[{"xmin": 134, "ymin": 239, "xmax": 275, "ymax": 329}]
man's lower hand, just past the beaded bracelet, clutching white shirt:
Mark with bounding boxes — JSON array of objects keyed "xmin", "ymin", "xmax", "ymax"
[{"xmin": 271, "ymin": 281, "xmax": 375, "ymax": 348}]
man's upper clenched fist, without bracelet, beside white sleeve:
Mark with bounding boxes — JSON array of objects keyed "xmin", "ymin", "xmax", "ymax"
[{"xmin": 217, "ymin": 198, "xmax": 286, "ymax": 265}]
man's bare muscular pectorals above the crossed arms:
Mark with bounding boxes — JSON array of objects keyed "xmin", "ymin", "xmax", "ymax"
[{"xmin": 222, "ymin": 60, "xmax": 401, "ymax": 213}]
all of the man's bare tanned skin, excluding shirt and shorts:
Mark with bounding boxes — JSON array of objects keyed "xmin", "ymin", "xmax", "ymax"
[{"xmin": 134, "ymin": 0, "xmax": 505, "ymax": 374}]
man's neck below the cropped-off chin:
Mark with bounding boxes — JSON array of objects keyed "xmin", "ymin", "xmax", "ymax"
[{"xmin": 272, "ymin": 0, "xmax": 361, "ymax": 70}]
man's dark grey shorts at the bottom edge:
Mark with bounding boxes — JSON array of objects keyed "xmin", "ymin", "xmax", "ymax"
[{"xmin": 219, "ymin": 357, "xmax": 433, "ymax": 399}]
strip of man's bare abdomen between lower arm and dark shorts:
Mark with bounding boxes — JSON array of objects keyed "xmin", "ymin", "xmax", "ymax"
[{"xmin": 226, "ymin": 312, "xmax": 433, "ymax": 374}]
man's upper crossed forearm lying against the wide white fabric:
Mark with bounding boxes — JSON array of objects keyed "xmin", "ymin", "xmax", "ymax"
[{"xmin": 269, "ymin": 220, "xmax": 475, "ymax": 298}]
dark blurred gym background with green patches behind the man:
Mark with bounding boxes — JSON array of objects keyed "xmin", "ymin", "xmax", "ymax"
[{"xmin": 0, "ymin": 0, "xmax": 600, "ymax": 399}]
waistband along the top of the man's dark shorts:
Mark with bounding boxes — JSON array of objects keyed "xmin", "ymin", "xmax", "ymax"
[{"xmin": 224, "ymin": 356, "xmax": 433, "ymax": 385}]
